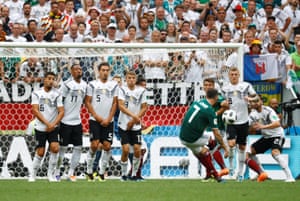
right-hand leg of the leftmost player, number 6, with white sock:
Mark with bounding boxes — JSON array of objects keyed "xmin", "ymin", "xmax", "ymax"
[{"xmin": 47, "ymin": 128, "xmax": 59, "ymax": 182}]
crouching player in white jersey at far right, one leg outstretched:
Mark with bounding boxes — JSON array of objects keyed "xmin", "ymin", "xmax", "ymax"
[{"xmin": 247, "ymin": 95, "xmax": 295, "ymax": 182}]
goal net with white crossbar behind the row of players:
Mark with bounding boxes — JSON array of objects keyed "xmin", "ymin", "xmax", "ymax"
[{"xmin": 0, "ymin": 43, "xmax": 243, "ymax": 178}]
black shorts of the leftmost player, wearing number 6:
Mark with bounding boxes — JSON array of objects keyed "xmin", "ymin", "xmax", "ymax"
[{"xmin": 35, "ymin": 127, "xmax": 59, "ymax": 148}]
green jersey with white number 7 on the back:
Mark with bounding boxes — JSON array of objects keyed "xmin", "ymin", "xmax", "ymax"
[{"xmin": 179, "ymin": 99, "xmax": 218, "ymax": 142}]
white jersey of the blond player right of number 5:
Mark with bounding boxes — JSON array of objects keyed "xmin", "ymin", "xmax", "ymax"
[{"xmin": 118, "ymin": 86, "xmax": 146, "ymax": 131}]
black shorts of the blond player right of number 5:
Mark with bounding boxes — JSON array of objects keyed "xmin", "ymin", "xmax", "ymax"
[{"xmin": 119, "ymin": 127, "xmax": 142, "ymax": 145}]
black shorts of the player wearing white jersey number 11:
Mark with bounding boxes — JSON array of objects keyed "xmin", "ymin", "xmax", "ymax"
[{"xmin": 59, "ymin": 123, "xmax": 82, "ymax": 146}]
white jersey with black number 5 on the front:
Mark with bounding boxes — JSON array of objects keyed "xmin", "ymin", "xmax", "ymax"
[{"xmin": 86, "ymin": 80, "xmax": 118, "ymax": 121}]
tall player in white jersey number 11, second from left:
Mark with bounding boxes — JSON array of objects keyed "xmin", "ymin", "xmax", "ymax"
[{"xmin": 56, "ymin": 64, "xmax": 87, "ymax": 181}]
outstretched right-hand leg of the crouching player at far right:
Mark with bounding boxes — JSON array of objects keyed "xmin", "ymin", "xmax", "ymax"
[{"xmin": 272, "ymin": 137, "xmax": 295, "ymax": 182}]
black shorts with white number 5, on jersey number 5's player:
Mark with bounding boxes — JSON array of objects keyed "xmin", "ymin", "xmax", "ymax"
[{"xmin": 89, "ymin": 120, "xmax": 114, "ymax": 144}]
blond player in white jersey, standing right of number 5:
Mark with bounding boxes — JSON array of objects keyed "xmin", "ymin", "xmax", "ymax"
[{"xmin": 118, "ymin": 71, "xmax": 147, "ymax": 181}]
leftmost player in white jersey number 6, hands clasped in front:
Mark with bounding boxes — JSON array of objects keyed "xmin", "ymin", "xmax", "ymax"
[{"xmin": 28, "ymin": 72, "xmax": 64, "ymax": 182}]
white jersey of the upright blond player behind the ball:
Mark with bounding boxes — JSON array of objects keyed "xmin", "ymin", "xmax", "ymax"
[{"xmin": 222, "ymin": 82, "xmax": 256, "ymax": 124}]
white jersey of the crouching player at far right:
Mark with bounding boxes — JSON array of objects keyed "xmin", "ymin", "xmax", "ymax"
[{"xmin": 249, "ymin": 105, "xmax": 284, "ymax": 138}]
